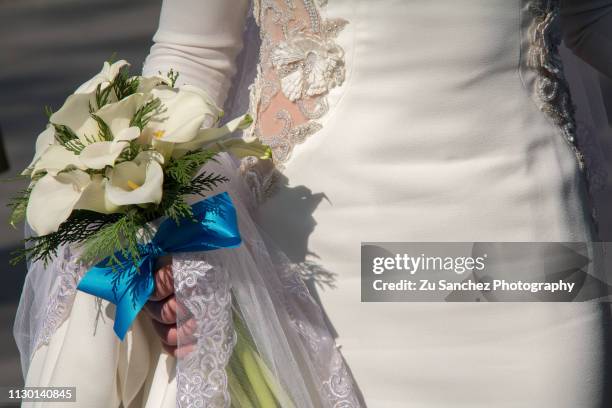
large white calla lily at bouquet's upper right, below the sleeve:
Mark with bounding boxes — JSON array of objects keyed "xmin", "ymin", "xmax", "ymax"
[{"xmin": 146, "ymin": 86, "xmax": 221, "ymax": 143}]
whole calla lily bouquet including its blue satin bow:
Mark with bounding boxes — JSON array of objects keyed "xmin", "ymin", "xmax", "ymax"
[{"xmin": 11, "ymin": 57, "xmax": 268, "ymax": 338}]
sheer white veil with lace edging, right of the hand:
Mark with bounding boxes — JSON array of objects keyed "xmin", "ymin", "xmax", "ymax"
[{"xmin": 173, "ymin": 154, "xmax": 362, "ymax": 408}]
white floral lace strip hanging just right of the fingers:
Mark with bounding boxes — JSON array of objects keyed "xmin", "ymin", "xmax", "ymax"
[{"xmin": 172, "ymin": 255, "xmax": 236, "ymax": 408}]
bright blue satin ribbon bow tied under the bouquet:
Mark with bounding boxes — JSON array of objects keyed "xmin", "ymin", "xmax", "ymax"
[{"xmin": 77, "ymin": 193, "xmax": 241, "ymax": 340}]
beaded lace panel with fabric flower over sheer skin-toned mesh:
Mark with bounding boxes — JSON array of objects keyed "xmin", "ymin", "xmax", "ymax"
[{"xmin": 250, "ymin": 0, "xmax": 348, "ymax": 167}]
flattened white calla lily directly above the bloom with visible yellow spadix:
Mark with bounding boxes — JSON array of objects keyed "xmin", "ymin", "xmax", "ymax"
[{"xmin": 79, "ymin": 126, "xmax": 140, "ymax": 170}]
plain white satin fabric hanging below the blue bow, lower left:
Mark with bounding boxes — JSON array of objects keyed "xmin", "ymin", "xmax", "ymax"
[{"xmin": 22, "ymin": 292, "xmax": 176, "ymax": 408}]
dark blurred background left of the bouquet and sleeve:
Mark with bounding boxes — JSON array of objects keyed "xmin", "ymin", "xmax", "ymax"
[{"xmin": 0, "ymin": 0, "xmax": 161, "ymax": 396}]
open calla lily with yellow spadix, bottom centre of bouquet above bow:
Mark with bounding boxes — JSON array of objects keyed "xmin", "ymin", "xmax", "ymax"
[{"xmin": 106, "ymin": 151, "xmax": 164, "ymax": 206}]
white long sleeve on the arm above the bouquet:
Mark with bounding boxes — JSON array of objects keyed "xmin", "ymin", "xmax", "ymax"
[{"xmin": 143, "ymin": 0, "xmax": 249, "ymax": 106}]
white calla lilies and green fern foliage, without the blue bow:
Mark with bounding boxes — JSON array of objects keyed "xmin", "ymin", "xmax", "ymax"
[{"xmin": 11, "ymin": 57, "xmax": 267, "ymax": 256}]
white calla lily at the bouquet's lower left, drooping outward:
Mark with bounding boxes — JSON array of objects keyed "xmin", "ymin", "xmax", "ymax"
[{"xmin": 26, "ymin": 170, "xmax": 91, "ymax": 235}]
